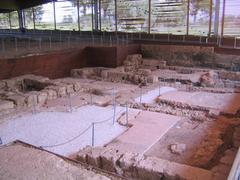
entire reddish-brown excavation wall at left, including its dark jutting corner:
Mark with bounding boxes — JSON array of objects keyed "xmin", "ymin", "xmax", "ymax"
[{"xmin": 0, "ymin": 45, "xmax": 140, "ymax": 79}]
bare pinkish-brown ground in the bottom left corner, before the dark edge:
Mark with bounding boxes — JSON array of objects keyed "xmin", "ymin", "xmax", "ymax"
[{"xmin": 0, "ymin": 143, "xmax": 110, "ymax": 180}]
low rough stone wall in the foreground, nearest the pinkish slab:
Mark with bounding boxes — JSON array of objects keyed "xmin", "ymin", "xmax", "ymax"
[{"xmin": 77, "ymin": 147, "xmax": 213, "ymax": 180}]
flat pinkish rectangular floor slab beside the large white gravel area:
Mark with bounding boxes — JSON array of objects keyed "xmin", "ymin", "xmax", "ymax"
[{"xmin": 108, "ymin": 111, "xmax": 180, "ymax": 153}]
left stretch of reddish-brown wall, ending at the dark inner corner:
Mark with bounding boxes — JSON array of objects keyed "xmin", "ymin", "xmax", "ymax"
[{"xmin": 0, "ymin": 49, "xmax": 86, "ymax": 79}]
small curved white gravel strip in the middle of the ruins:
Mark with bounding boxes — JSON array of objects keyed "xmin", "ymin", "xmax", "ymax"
[{"xmin": 135, "ymin": 87, "xmax": 177, "ymax": 103}]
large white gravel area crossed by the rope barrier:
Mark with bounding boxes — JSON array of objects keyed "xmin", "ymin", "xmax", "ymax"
[{"xmin": 0, "ymin": 105, "xmax": 126, "ymax": 156}]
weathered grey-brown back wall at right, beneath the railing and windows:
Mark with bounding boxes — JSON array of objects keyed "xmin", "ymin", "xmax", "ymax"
[{"xmin": 141, "ymin": 45, "xmax": 240, "ymax": 71}]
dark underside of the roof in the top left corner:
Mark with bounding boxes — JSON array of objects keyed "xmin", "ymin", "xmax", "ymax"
[{"xmin": 0, "ymin": 0, "xmax": 57, "ymax": 13}]
